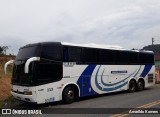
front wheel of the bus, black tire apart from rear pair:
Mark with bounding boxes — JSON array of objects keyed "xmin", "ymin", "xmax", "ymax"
[{"xmin": 62, "ymin": 86, "xmax": 76, "ymax": 104}]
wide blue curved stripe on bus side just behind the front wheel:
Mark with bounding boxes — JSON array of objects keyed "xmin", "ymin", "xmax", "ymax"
[{"xmin": 77, "ymin": 65, "xmax": 97, "ymax": 96}]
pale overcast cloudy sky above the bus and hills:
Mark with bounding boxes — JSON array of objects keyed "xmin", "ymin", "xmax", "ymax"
[{"xmin": 0, "ymin": 0, "xmax": 160, "ymax": 54}]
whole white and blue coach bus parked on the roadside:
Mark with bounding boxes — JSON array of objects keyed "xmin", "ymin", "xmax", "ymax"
[{"xmin": 5, "ymin": 42, "xmax": 155, "ymax": 104}]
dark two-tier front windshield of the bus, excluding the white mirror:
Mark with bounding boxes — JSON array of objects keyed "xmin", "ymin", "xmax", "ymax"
[{"xmin": 12, "ymin": 46, "xmax": 40, "ymax": 86}]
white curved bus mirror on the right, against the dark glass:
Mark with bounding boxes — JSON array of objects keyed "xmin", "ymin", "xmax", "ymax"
[{"xmin": 24, "ymin": 57, "xmax": 40, "ymax": 74}]
